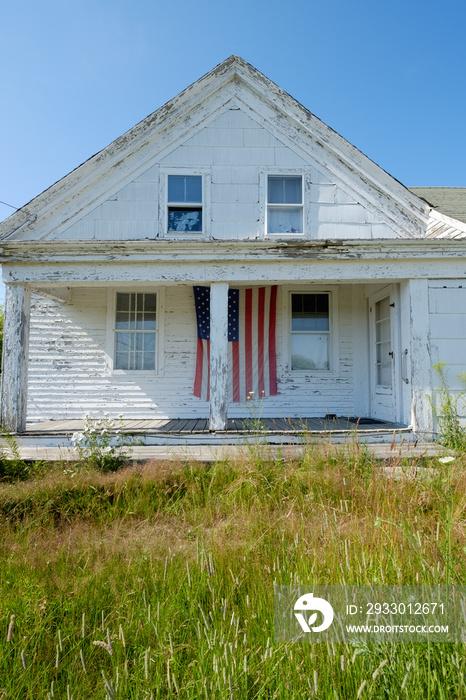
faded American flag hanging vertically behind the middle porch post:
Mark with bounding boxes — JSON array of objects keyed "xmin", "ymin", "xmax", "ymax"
[{"xmin": 194, "ymin": 285, "xmax": 277, "ymax": 403}]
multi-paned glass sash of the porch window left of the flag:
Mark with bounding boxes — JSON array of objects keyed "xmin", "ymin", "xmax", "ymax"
[{"xmin": 114, "ymin": 292, "xmax": 157, "ymax": 370}]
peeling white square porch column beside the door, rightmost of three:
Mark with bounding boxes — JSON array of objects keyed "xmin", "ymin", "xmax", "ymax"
[{"xmin": 408, "ymin": 280, "xmax": 433, "ymax": 438}]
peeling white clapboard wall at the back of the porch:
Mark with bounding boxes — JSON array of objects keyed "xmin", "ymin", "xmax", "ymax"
[{"xmin": 28, "ymin": 286, "xmax": 355, "ymax": 422}]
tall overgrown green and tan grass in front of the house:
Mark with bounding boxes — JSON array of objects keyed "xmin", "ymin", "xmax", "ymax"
[{"xmin": 0, "ymin": 445, "xmax": 466, "ymax": 700}]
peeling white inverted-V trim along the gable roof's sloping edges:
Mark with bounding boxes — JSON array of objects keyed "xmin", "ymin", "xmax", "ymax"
[{"xmin": 0, "ymin": 56, "xmax": 429, "ymax": 241}]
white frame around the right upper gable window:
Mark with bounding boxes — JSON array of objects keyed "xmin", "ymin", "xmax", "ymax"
[{"xmin": 259, "ymin": 168, "xmax": 312, "ymax": 239}]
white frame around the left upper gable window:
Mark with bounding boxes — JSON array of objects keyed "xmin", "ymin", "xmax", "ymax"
[{"xmin": 159, "ymin": 167, "xmax": 211, "ymax": 240}]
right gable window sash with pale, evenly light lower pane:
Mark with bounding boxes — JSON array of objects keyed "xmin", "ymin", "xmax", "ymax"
[{"xmin": 267, "ymin": 175, "xmax": 304, "ymax": 234}]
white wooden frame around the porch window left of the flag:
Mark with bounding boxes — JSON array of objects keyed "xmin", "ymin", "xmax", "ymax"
[{"xmin": 106, "ymin": 286, "xmax": 165, "ymax": 378}]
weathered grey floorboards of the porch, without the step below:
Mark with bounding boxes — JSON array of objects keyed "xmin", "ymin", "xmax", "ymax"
[{"xmin": 23, "ymin": 417, "xmax": 411, "ymax": 437}]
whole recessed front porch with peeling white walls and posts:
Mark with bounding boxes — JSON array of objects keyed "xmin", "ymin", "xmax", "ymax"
[{"xmin": 2, "ymin": 270, "xmax": 431, "ymax": 444}]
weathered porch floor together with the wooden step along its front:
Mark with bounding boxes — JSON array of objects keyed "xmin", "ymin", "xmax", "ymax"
[{"xmin": 0, "ymin": 417, "xmax": 447, "ymax": 462}]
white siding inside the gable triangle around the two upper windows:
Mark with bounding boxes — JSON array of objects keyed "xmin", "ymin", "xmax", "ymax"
[{"xmin": 53, "ymin": 109, "xmax": 399, "ymax": 240}]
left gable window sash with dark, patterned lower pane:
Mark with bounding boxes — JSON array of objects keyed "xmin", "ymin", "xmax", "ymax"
[{"xmin": 167, "ymin": 175, "xmax": 203, "ymax": 233}]
